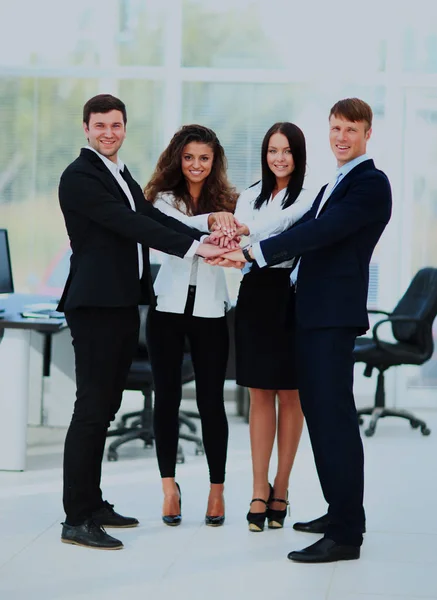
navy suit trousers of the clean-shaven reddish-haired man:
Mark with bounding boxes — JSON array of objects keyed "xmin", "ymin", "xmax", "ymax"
[{"xmin": 296, "ymin": 328, "xmax": 364, "ymax": 546}]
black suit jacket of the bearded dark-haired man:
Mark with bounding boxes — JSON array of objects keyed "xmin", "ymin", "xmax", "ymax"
[{"xmin": 58, "ymin": 148, "xmax": 202, "ymax": 311}]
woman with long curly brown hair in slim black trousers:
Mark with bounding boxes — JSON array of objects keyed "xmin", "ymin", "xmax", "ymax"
[{"xmin": 144, "ymin": 125, "xmax": 237, "ymax": 526}]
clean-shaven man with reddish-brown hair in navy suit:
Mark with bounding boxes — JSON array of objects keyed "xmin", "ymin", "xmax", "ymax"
[{"xmin": 216, "ymin": 98, "xmax": 391, "ymax": 562}]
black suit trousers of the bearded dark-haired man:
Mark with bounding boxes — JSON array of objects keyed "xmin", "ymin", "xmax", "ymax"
[{"xmin": 63, "ymin": 307, "xmax": 139, "ymax": 525}]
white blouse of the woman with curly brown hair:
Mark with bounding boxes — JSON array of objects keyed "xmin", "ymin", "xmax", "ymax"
[{"xmin": 154, "ymin": 193, "xmax": 230, "ymax": 318}]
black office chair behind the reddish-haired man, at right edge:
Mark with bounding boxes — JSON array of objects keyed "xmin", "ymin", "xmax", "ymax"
[{"xmin": 354, "ymin": 267, "xmax": 437, "ymax": 437}]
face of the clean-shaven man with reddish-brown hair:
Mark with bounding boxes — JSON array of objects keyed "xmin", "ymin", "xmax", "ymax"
[{"xmin": 329, "ymin": 115, "xmax": 372, "ymax": 167}]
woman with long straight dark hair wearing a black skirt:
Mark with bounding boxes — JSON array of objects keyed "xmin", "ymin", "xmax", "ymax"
[{"xmin": 217, "ymin": 122, "xmax": 312, "ymax": 531}]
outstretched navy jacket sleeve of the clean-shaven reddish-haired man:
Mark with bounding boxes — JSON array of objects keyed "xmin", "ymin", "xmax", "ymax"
[{"xmin": 260, "ymin": 172, "xmax": 391, "ymax": 265}]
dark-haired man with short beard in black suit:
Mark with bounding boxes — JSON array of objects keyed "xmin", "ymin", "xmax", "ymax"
[{"xmin": 58, "ymin": 94, "xmax": 220, "ymax": 549}]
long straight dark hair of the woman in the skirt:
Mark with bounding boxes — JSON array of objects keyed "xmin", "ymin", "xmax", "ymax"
[{"xmin": 254, "ymin": 121, "xmax": 307, "ymax": 209}]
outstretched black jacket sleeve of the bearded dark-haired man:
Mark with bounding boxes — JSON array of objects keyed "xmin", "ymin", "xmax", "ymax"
[{"xmin": 59, "ymin": 171, "xmax": 200, "ymax": 258}]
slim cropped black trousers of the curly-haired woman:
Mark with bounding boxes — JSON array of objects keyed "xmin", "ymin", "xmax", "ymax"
[{"xmin": 147, "ymin": 296, "xmax": 229, "ymax": 483}]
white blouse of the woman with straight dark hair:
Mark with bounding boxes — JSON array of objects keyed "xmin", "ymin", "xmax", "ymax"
[{"xmin": 235, "ymin": 181, "xmax": 314, "ymax": 268}]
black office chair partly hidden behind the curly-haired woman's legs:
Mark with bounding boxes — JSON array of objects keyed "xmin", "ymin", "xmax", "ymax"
[{"xmin": 107, "ymin": 306, "xmax": 204, "ymax": 463}]
